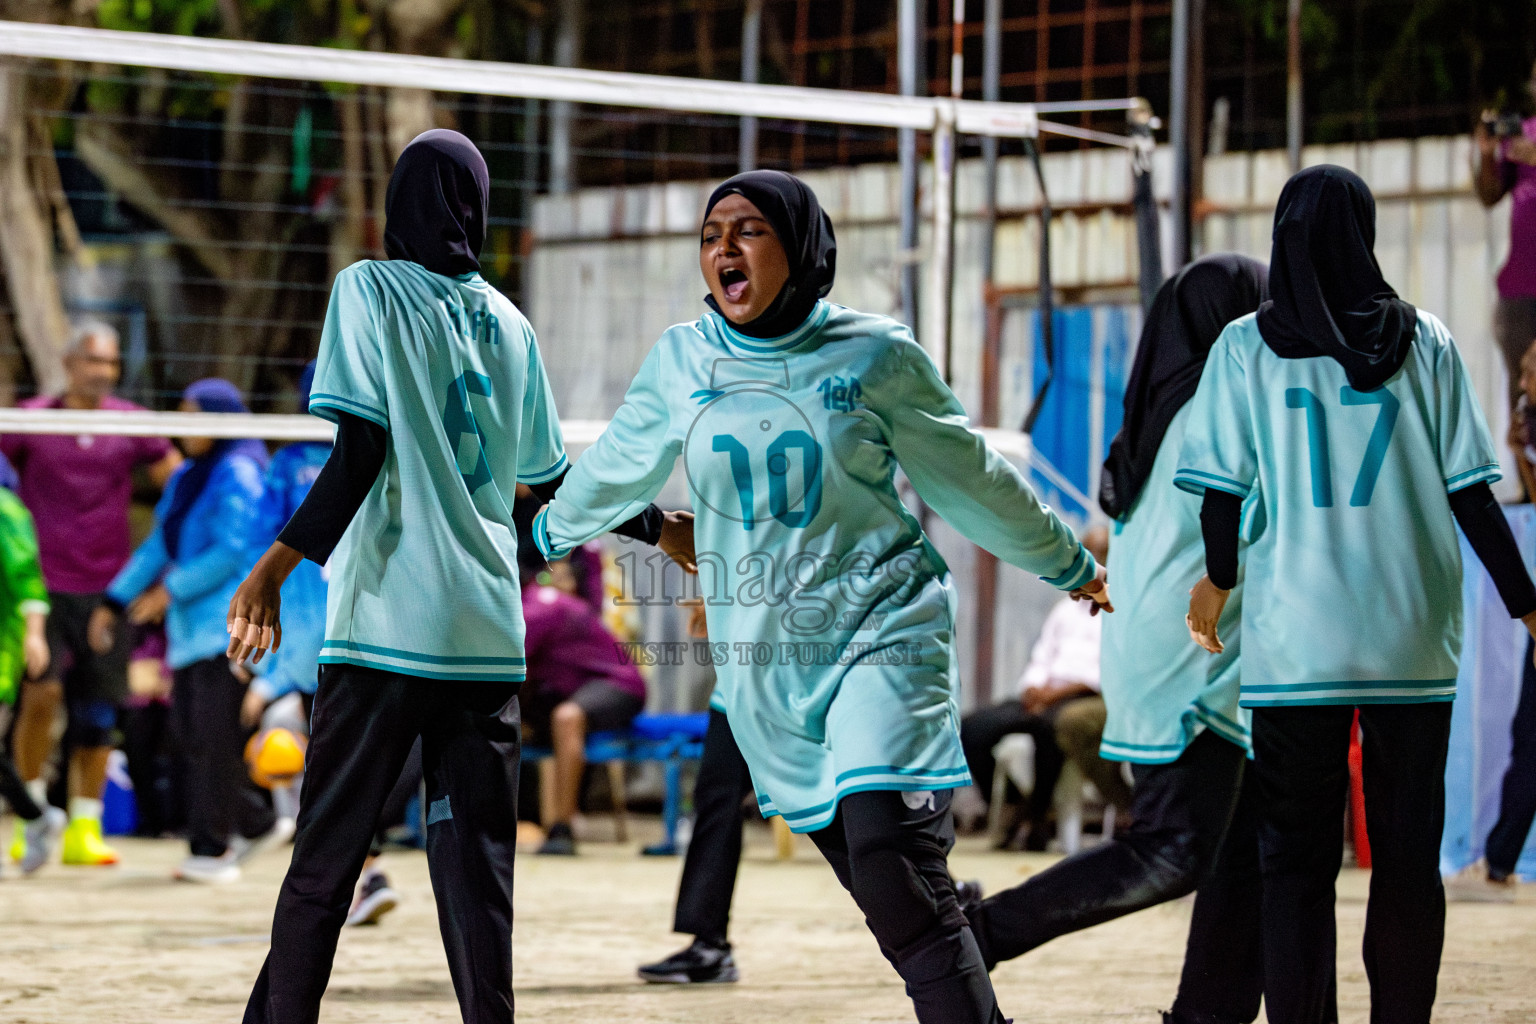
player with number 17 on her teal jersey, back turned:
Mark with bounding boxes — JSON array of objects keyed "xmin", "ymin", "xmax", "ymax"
[{"xmin": 1175, "ymin": 166, "xmax": 1536, "ymax": 1024}]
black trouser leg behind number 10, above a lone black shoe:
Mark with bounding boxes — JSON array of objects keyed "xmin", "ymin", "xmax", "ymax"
[{"xmin": 673, "ymin": 708, "xmax": 753, "ymax": 943}]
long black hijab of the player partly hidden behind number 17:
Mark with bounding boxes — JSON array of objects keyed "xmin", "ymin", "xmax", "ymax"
[{"xmin": 1098, "ymin": 253, "xmax": 1267, "ymax": 519}]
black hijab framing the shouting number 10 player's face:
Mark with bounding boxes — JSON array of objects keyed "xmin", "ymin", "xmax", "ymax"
[{"xmin": 703, "ymin": 170, "xmax": 837, "ymax": 338}]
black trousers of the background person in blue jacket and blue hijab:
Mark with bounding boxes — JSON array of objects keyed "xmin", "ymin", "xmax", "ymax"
[{"xmin": 172, "ymin": 654, "xmax": 276, "ymax": 857}]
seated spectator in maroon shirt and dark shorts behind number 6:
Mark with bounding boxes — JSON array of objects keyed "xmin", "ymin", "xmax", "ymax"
[{"xmin": 522, "ymin": 564, "xmax": 645, "ymax": 855}]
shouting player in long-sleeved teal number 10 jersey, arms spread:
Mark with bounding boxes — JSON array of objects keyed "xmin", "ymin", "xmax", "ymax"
[{"xmin": 535, "ymin": 170, "xmax": 1107, "ymax": 1024}]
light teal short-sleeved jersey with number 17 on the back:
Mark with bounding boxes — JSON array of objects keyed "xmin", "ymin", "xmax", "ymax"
[{"xmin": 1175, "ymin": 310, "xmax": 1499, "ymax": 708}]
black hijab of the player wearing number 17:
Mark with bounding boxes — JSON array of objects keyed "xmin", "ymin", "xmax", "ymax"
[{"xmin": 1258, "ymin": 164, "xmax": 1419, "ymax": 391}]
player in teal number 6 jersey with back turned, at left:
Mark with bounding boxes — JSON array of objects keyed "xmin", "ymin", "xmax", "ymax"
[{"xmin": 229, "ymin": 130, "xmax": 681, "ymax": 1024}]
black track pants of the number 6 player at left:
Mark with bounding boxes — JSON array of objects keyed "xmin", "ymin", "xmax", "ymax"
[{"xmin": 244, "ymin": 665, "xmax": 521, "ymax": 1024}]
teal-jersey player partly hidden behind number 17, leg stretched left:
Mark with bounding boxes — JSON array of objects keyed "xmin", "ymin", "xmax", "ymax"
[{"xmin": 968, "ymin": 253, "xmax": 1266, "ymax": 1024}]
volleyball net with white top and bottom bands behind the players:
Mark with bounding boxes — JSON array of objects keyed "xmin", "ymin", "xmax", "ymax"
[{"xmin": 0, "ymin": 23, "xmax": 1138, "ymax": 521}]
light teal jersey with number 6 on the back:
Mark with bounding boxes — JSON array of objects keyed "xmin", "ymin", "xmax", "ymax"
[{"xmin": 309, "ymin": 259, "xmax": 565, "ymax": 680}]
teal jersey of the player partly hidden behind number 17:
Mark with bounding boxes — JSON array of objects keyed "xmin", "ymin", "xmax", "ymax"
[{"xmin": 1100, "ymin": 402, "xmax": 1256, "ymax": 765}]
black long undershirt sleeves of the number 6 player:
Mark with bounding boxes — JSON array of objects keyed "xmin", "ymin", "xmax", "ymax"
[{"xmin": 278, "ymin": 413, "xmax": 664, "ymax": 565}]
